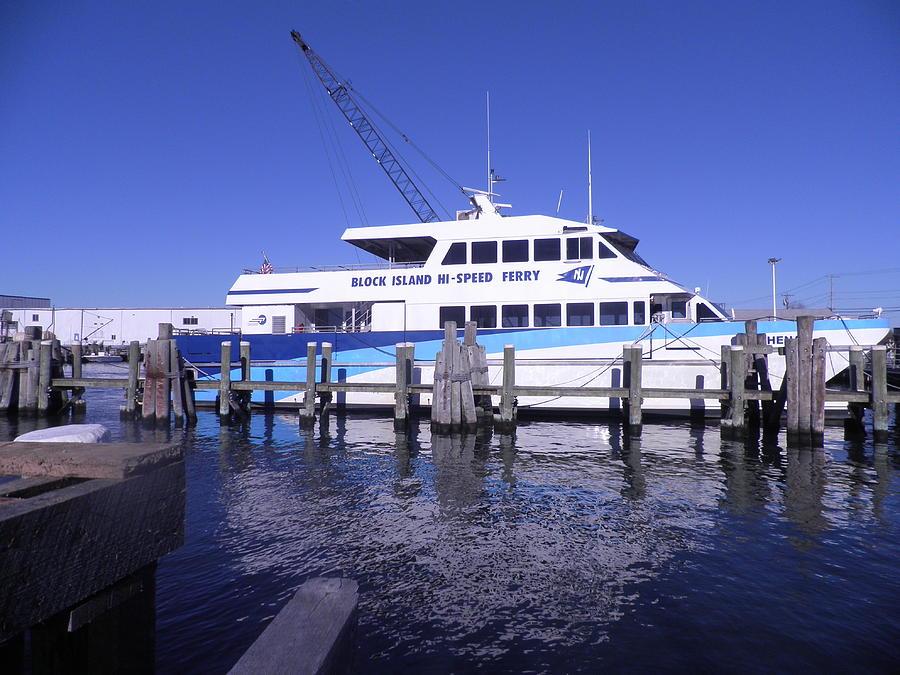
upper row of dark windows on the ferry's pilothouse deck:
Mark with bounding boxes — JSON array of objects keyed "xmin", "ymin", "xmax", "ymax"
[{"xmin": 441, "ymin": 237, "xmax": 616, "ymax": 265}]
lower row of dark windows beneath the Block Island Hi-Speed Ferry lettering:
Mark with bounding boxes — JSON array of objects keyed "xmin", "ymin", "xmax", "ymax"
[{"xmin": 438, "ymin": 301, "xmax": 647, "ymax": 328}]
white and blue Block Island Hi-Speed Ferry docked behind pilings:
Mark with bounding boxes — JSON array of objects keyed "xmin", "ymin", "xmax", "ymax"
[{"xmin": 177, "ymin": 190, "xmax": 889, "ymax": 416}]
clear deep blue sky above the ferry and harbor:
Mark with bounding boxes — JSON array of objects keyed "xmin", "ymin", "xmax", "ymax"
[{"xmin": 0, "ymin": 0, "xmax": 900, "ymax": 322}]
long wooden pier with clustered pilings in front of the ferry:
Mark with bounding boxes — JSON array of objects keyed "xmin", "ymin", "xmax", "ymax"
[{"xmin": 0, "ymin": 317, "xmax": 900, "ymax": 444}]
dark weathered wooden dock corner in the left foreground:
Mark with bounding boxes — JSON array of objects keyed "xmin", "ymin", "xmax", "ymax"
[{"xmin": 0, "ymin": 442, "xmax": 185, "ymax": 673}]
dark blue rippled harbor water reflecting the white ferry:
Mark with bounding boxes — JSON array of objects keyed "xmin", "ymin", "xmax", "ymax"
[{"xmin": 0, "ymin": 365, "xmax": 900, "ymax": 673}]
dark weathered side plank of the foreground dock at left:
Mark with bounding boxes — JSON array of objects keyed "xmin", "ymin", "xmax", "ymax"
[{"xmin": 0, "ymin": 462, "xmax": 184, "ymax": 642}]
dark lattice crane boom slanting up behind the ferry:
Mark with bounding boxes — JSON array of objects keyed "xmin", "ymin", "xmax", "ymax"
[{"xmin": 291, "ymin": 30, "xmax": 440, "ymax": 223}]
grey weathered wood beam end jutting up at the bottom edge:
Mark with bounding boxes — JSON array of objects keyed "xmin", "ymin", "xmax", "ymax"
[{"xmin": 230, "ymin": 578, "xmax": 359, "ymax": 675}]
